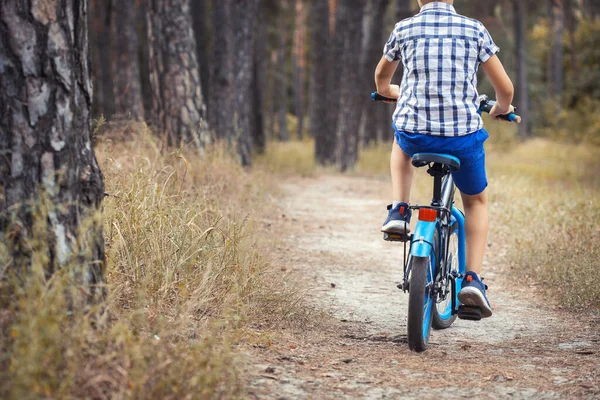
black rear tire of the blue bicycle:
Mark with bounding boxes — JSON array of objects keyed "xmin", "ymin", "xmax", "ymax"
[{"xmin": 407, "ymin": 257, "xmax": 434, "ymax": 352}]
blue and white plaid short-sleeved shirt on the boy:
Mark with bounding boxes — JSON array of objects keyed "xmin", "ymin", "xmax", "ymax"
[{"xmin": 384, "ymin": 2, "xmax": 500, "ymax": 136}]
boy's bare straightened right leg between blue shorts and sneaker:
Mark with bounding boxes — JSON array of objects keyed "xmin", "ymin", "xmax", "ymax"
[{"xmin": 461, "ymin": 190, "xmax": 488, "ymax": 275}]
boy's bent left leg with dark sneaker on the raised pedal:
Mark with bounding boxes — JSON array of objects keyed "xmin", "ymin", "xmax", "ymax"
[{"xmin": 381, "ymin": 139, "xmax": 413, "ymax": 234}]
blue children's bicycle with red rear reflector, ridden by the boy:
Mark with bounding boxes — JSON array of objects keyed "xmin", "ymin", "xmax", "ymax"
[{"xmin": 372, "ymin": 93, "xmax": 520, "ymax": 352}]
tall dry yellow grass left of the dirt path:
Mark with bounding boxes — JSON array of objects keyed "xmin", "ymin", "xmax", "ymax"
[{"xmin": 0, "ymin": 122, "xmax": 299, "ymax": 399}]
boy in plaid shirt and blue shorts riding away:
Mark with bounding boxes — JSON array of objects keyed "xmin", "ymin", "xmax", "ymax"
[{"xmin": 375, "ymin": 0, "xmax": 514, "ymax": 318}]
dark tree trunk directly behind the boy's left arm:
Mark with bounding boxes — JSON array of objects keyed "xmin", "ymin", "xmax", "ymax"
[{"xmin": 360, "ymin": 0, "xmax": 391, "ymax": 145}]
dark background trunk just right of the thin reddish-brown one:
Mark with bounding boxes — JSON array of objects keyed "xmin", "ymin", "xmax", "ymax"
[{"xmin": 308, "ymin": 1, "xmax": 333, "ymax": 165}]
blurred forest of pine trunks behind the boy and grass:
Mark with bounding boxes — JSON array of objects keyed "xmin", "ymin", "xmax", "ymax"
[{"xmin": 89, "ymin": 0, "xmax": 600, "ymax": 171}]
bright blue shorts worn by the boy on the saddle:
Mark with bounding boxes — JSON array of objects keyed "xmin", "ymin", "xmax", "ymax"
[{"xmin": 395, "ymin": 129, "xmax": 489, "ymax": 196}]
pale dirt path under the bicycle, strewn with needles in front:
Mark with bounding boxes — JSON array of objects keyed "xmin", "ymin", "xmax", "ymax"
[{"xmin": 247, "ymin": 176, "xmax": 600, "ymax": 399}]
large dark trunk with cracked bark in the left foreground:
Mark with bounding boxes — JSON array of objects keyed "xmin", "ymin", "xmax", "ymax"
[{"xmin": 0, "ymin": 0, "xmax": 104, "ymax": 301}]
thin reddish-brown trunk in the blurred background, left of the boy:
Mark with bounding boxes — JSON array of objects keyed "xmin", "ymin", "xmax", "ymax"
[{"xmin": 293, "ymin": 0, "xmax": 306, "ymax": 140}]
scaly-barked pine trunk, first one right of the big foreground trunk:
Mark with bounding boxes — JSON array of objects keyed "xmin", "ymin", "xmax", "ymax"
[{"xmin": 148, "ymin": 0, "xmax": 210, "ymax": 150}]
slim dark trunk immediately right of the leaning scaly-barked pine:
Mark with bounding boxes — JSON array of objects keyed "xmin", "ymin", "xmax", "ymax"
[{"xmin": 208, "ymin": 0, "xmax": 235, "ymax": 145}]
